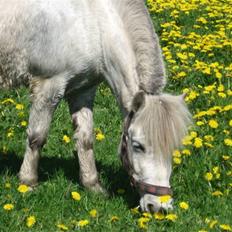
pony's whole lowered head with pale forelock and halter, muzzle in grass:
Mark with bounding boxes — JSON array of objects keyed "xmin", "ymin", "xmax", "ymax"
[{"xmin": 120, "ymin": 91, "xmax": 191, "ymax": 212}]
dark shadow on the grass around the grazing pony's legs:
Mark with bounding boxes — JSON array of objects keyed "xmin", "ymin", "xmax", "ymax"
[{"xmin": 0, "ymin": 153, "xmax": 139, "ymax": 208}]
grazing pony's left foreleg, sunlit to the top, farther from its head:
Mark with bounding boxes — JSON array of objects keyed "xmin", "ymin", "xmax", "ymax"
[{"xmin": 19, "ymin": 75, "xmax": 65, "ymax": 186}]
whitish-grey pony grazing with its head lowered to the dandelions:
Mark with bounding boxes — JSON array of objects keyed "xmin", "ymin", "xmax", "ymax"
[{"xmin": 0, "ymin": 0, "xmax": 190, "ymax": 212}]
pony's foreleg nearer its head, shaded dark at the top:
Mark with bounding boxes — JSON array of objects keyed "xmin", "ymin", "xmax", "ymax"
[{"xmin": 68, "ymin": 87, "xmax": 105, "ymax": 192}]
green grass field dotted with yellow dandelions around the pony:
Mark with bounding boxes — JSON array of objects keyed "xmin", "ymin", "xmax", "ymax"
[{"xmin": 0, "ymin": 0, "xmax": 232, "ymax": 232}]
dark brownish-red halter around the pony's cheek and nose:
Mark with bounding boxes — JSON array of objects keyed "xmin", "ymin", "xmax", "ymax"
[{"xmin": 120, "ymin": 111, "xmax": 172, "ymax": 196}]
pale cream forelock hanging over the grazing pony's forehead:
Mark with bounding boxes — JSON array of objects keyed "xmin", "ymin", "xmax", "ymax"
[{"xmin": 138, "ymin": 94, "xmax": 191, "ymax": 156}]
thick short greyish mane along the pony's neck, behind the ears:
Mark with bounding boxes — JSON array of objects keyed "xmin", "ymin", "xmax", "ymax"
[{"xmin": 113, "ymin": 0, "xmax": 166, "ymax": 94}]
